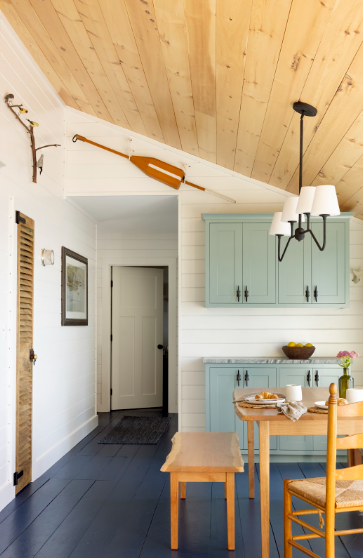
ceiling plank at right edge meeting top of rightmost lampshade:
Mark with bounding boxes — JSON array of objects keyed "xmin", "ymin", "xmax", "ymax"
[{"xmin": 312, "ymin": 112, "xmax": 363, "ymax": 186}]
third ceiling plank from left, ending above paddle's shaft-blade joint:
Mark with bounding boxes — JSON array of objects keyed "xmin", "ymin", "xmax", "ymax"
[{"xmin": 51, "ymin": 0, "xmax": 129, "ymax": 127}]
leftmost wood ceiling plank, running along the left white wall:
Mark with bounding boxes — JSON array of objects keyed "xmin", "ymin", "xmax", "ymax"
[{"xmin": 1, "ymin": 2, "xmax": 80, "ymax": 110}]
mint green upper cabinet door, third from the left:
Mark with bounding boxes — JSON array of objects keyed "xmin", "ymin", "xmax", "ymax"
[{"xmin": 278, "ymin": 235, "xmax": 312, "ymax": 305}]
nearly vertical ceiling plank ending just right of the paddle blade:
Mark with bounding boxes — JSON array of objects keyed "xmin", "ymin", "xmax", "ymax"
[{"xmin": 184, "ymin": 0, "xmax": 217, "ymax": 163}]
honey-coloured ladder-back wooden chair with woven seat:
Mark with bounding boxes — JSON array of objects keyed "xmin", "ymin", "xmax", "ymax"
[{"xmin": 284, "ymin": 384, "xmax": 363, "ymax": 558}]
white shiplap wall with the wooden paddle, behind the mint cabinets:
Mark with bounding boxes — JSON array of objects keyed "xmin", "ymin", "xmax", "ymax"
[{"xmin": 66, "ymin": 109, "xmax": 363, "ymax": 430}]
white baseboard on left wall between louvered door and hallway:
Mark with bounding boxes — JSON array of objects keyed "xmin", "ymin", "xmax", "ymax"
[{"xmin": 33, "ymin": 415, "xmax": 98, "ymax": 481}]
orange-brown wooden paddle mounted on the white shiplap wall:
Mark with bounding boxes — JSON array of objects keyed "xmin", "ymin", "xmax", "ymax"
[{"xmin": 72, "ymin": 134, "xmax": 236, "ymax": 203}]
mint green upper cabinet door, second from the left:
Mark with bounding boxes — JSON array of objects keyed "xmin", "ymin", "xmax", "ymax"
[{"xmin": 242, "ymin": 222, "xmax": 276, "ymax": 304}]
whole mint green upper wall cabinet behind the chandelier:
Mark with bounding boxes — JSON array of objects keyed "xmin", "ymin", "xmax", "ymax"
[{"xmin": 202, "ymin": 213, "xmax": 352, "ymax": 308}]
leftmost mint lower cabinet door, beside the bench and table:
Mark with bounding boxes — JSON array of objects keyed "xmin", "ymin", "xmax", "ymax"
[{"xmin": 207, "ymin": 368, "xmax": 244, "ymax": 448}]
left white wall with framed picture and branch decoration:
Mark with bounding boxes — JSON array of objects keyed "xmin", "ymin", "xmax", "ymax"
[{"xmin": 0, "ymin": 14, "xmax": 97, "ymax": 509}]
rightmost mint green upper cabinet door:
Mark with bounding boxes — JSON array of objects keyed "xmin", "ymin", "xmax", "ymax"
[{"xmin": 311, "ymin": 218, "xmax": 349, "ymax": 304}]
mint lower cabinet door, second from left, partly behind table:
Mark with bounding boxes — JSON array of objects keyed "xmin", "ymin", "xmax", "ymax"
[{"xmin": 243, "ymin": 367, "xmax": 277, "ymax": 450}]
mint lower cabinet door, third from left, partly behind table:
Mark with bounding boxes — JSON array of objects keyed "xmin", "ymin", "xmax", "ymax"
[{"xmin": 279, "ymin": 366, "xmax": 315, "ymax": 453}]
